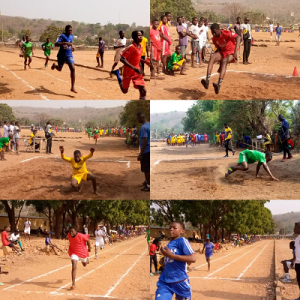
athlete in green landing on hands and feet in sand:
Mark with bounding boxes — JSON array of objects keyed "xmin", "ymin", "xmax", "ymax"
[{"xmin": 225, "ymin": 149, "xmax": 279, "ymax": 181}]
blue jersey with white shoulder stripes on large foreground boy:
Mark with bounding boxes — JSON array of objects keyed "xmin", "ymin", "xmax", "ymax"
[{"xmin": 159, "ymin": 237, "xmax": 195, "ymax": 283}]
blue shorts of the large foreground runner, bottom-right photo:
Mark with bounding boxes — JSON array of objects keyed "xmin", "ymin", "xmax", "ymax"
[{"xmin": 155, "ymin": 279, "xmax": 192, "ymax": 300}]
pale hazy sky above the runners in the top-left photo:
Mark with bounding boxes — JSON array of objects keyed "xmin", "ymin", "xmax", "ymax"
[{"xmin": 0, "ymin": 0, "xmax": 150, "ymax": 26}]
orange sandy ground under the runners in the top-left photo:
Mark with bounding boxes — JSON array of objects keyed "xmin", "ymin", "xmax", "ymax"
[{"xmin": 0, "ymin": 48, "xmax": 150, "ymax": 100}]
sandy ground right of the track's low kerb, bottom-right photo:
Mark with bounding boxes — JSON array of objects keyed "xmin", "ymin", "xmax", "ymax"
[{"xmin": 275, "ymin": 239, "xmax": 299, "ymax": 300}]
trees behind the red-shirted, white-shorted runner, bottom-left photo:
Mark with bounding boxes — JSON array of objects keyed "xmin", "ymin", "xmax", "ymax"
[{"xmin": 0, "ymin": 200, "xmax": 150, "ymax": 238}]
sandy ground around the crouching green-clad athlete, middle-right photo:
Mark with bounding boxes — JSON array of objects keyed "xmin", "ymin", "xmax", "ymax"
[{"xmin": 151, "ymin": 143, "xmax": 300, "ymax": 200}]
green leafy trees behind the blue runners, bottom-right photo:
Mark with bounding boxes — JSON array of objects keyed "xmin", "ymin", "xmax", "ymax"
[{"xmin": 150, "ymin": 200, "xmax": 275, "ymax": 240}]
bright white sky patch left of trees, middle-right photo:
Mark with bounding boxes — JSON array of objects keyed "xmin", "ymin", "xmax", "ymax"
[{"xmin": 150, "ymin": 100, "xmax": 195, "ymax": 114}]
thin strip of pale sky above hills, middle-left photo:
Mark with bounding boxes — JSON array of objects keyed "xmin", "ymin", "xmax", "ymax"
[{"xmin": 0, "ymin": 100, "xmax": 128, "ymax": 108}]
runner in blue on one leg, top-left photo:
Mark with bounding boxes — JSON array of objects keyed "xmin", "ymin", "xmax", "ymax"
[{"xmin": 51, "ymin": 25, "xmax": 77, "ymax": 93}]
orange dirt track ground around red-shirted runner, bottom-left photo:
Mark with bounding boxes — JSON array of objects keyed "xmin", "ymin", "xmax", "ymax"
[{"xmin": 0, "ymin": 236, "xmax": 149, "ymax": 300}]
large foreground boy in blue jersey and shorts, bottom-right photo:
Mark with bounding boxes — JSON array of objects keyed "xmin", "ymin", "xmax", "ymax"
[{"xmin": 155, "ymin": 222, "xmax": 196, "ymax": 300}]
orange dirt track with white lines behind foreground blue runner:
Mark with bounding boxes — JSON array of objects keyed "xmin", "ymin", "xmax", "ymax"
[{"xmin": 150, "ymin": 240, "xmax": 275, "ymax": 300}]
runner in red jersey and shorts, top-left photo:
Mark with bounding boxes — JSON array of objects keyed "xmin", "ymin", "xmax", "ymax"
[{"xmin": 111, "ymin": 30, "xmax": 149, "ymax": 100}]
